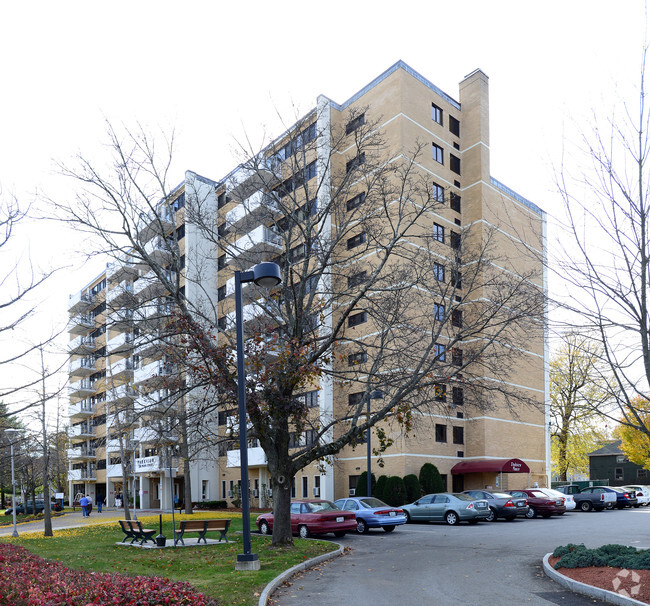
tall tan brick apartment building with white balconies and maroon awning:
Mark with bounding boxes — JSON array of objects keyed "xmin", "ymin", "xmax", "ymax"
[{"xmin": 69, "ymin": 61, "xmax": 550, "ymax": 507}]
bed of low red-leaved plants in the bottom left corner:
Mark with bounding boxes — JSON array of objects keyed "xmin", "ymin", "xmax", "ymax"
[{"xmin": 0, "ymin": 544, "xmax": 217, "ymax": 606}]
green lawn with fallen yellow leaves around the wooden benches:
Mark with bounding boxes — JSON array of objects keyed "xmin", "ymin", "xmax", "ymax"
[{"xmin": 2, "ymin": 511, "xmax": 335, "ymax": 606}]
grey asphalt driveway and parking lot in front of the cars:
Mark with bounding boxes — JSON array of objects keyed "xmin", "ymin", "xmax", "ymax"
[{"xmin": 272, "ymin": 507, "xmax": 650, "ymax": 606}]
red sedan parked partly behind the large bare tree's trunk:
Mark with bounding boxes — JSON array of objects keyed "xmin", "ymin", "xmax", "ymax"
[{"xmin": 257, "ymin": 499, "xmax": 357, "ymax": 539}]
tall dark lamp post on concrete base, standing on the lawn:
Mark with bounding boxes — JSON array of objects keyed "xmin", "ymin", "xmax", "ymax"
[{"xmin": 235, "ymin": 263, "xmax": 282, "ymax": 570}]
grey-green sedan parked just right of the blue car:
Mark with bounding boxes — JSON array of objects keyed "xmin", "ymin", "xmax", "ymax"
[{"xmin": 402, "ymin": 492, "xmax": 491, "ymax": 526}]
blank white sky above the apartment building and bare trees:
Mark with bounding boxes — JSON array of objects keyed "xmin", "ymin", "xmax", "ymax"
[{"xmin": 0, "ymin": 0, "xmax": 646, "ymax": 422}]
